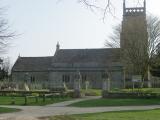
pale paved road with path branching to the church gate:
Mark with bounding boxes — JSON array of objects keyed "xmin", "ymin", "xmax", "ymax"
[{"xmin": 0, "ymin": 97, "xmax": 160, "ymax": 120}]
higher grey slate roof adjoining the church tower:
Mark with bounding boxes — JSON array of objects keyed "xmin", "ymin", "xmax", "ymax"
[{"xmin": 52, "ymin": 48, "xmax": 120, "ymax": 63}]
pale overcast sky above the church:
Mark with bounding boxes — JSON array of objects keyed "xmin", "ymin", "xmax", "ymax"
[{"xmin": 0, "ymin": 0, "xmax": 160, "ymax": 62}]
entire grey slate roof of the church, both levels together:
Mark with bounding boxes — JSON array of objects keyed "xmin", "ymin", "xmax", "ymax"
[{"xmin": 12, "ymin": 48, "xmax": 120, "ymax": 72}]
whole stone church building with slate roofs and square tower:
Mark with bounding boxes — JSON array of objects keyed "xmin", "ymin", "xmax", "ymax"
[{"xmin": 12, "ymin": 1, "xmax": 147, "ymax": 89}]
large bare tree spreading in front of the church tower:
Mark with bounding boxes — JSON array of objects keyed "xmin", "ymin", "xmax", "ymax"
[{"xmin": 105, "ymin": 15, "xmax": 160, "ymax": 83}]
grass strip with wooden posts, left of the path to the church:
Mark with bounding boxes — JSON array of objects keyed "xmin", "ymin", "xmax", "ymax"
[{"xmin": 0, "ymin": 96, "xmax": 71, "ymax": 105}]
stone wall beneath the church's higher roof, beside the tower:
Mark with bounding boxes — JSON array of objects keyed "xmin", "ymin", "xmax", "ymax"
[{"xmin": 49, "ymin": 71, "xmax": 124, "ymax": 89}]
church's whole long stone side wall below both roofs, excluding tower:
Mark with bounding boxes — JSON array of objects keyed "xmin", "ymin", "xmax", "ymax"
[{"xmin": 12, "ymin": 71, "xmax": 124, "ymax": 89}]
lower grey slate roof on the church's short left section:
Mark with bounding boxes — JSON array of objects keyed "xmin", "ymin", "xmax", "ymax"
[{"xmin": 12, "ymin": 56, "xmax": 52, "ymax": 71}]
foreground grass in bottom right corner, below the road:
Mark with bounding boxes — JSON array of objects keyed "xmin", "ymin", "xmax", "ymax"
[{"xmin": 50, "ymin": 109, "xmax": 160, "ymax": 120}]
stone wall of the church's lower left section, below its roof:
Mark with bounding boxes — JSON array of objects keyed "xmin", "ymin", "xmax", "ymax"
[{"xmin": 12, "ymin": 72, "xmax": 49, "ymax": 89}]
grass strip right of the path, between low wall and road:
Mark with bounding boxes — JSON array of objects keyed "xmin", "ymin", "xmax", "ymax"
[{"xmin": 69, "ymin": 98, "xmax": 160, "ymax": 107}]
